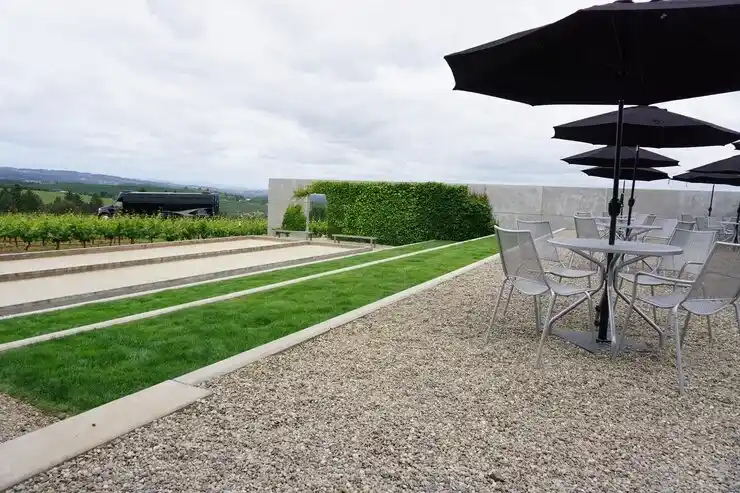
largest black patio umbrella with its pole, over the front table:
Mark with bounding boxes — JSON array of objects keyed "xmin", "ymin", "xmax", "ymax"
[{"xmin": 445, "ymin": 0, "xmax": 740, "ymax": 342}]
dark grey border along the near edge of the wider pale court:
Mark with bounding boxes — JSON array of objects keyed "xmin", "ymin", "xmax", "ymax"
[{"xmin": 0, "ymin": 249, "xmax": 369, "ymax": 316}]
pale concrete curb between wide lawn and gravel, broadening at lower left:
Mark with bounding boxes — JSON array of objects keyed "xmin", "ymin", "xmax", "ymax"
[{"xmin": 0, "ymin": 238, "xmax": 498, "ymax": 489}]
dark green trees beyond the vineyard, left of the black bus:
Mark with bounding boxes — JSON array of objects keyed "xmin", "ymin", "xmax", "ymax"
[{"xmin": 0, "ymin": 185, "xmax": 103, "ymax": 214}]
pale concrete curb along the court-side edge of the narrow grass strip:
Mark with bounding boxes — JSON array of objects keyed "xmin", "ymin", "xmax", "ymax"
[{"xmin": 0, "ymin": 237, "xmax": 428, "ymax": 321}]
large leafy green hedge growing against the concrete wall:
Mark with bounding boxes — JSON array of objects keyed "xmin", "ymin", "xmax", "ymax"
[{"xmin": 296, "ymin": 181, "xmax": 494, "ymax": 245}]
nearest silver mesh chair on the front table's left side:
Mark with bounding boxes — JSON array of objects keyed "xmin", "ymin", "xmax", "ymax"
[{"xmin": 486, "ymin": 226, "xmax": 601, "ymax": 356}]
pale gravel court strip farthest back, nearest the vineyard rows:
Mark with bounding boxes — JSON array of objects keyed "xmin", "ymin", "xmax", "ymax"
[{"xmin": 0, "ymin": 239, "xmax": 280, "ymax": 274}]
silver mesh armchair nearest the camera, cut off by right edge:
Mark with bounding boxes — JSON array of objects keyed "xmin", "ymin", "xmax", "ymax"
[{"xmin": 612, "ymin": 242, "xmax": 740, "ymax": 394}]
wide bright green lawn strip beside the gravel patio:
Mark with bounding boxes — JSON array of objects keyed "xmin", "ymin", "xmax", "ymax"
[{"xmin": 0, "ymin": 238, "xmax": 496, "ymax": 413}]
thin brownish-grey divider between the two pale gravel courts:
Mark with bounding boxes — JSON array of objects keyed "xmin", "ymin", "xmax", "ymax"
[{"xmin": 0, "ymin": 241, "xmax": 311, "ymax": 282}]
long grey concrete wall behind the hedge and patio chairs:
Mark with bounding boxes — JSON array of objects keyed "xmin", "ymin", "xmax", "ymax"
[{"xmin": 267, "ymin": 178, "xmax": 740, "ymax": 229}]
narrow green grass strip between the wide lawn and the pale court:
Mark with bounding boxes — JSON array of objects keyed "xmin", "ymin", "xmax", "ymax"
[{"xmin": 0, "ymin": 241, "xmax": 449, "ymax": 343}]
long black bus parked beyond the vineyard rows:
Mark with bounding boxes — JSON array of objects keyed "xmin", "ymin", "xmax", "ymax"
[{"xmin": 98, "ymin": 191, "xmax": 219, "ymax": 217}]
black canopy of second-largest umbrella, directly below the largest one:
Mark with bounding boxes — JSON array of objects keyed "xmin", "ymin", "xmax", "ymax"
[{"xmin": 554, "ymin": 106, "xmax": 740, "ymax": 147}]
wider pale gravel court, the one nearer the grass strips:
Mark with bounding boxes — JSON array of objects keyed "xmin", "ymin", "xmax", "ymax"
[{"xmin": 0, "ymin": 240, "xmax": 351, "ymax": 310}]
